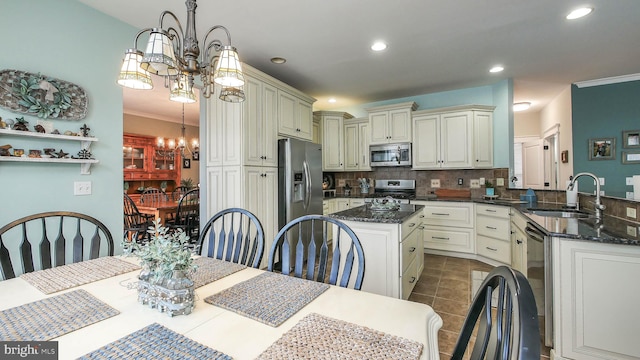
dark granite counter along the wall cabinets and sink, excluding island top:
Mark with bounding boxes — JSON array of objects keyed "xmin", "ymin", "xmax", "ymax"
[{"xmin": 416, "ymin": 197, "xmax": 640, "ymax": 246}]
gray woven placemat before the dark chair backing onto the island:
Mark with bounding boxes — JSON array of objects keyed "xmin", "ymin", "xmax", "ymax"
[{"xmin": 204, "ymin": 272, "xmax": 329, "ymax": 327}]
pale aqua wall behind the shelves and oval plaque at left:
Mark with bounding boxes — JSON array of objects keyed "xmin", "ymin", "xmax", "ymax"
[{"xmin": 0, "ymin": 0, "xmax": 137, "ymax": 249}]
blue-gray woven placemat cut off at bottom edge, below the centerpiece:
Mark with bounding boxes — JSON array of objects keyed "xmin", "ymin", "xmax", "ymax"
[{"xmin": 79, "ymin": 323, "xmax": 231, "ymax": 360}]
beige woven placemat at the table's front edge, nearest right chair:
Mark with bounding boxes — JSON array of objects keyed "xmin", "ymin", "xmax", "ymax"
[{"xmin": 258, "ymin": 314, "xmax": 423, "ymax": 360}]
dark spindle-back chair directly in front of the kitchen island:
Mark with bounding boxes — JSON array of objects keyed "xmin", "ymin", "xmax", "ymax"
[{"xmin": 268, "ymin": 215, "xmax": 364, "ymax": 290}]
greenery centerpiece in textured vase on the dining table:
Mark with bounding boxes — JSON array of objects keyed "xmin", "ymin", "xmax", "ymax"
[{"xmin": 122, "ymin": 219, "xmax": 197, "ymax": 316}]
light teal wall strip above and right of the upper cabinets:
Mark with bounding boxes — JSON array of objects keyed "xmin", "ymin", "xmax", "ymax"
[{"xmin": 335, "ymin": 79, "xmax": 513, "ymax": 168}]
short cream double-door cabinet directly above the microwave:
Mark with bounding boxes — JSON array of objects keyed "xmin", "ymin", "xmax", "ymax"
[{"xmin": 366, "ymin": 102, "xmax": 418, "ymax": 145}]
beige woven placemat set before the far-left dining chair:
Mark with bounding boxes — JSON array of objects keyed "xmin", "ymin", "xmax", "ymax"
[{"xmin": 20, "ymin": 256, "xmax": 140, "ymax": 294}]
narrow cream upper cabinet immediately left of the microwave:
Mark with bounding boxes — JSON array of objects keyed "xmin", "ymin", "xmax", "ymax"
[{"xmin": 344, "ymin": 119, "xmax": 371, "ymax": 171}]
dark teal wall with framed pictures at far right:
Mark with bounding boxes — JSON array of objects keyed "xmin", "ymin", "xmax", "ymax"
[{"xmin": 571, "ymin": 81, "xmax": 640, "ymax": 198}]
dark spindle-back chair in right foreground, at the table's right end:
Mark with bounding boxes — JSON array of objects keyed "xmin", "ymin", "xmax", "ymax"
[{"xmin": 451, "ymin": 266, "xmax": 541, "ymax": 360}]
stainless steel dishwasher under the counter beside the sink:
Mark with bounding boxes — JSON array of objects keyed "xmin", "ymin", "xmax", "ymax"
[{"xmin": 525, "ymin": 221, "xmax": 553, "ymax": 347}]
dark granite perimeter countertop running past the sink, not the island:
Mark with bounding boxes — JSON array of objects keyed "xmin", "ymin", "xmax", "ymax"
[{"xmin": 415, "ymin": 197, "xmax": 640, "ymax": 246}]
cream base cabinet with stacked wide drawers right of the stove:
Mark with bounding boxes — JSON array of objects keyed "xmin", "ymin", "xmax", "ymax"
[{"xmin": 411, "ymin": 200, "xmax": 475, "ymax": 254}]
